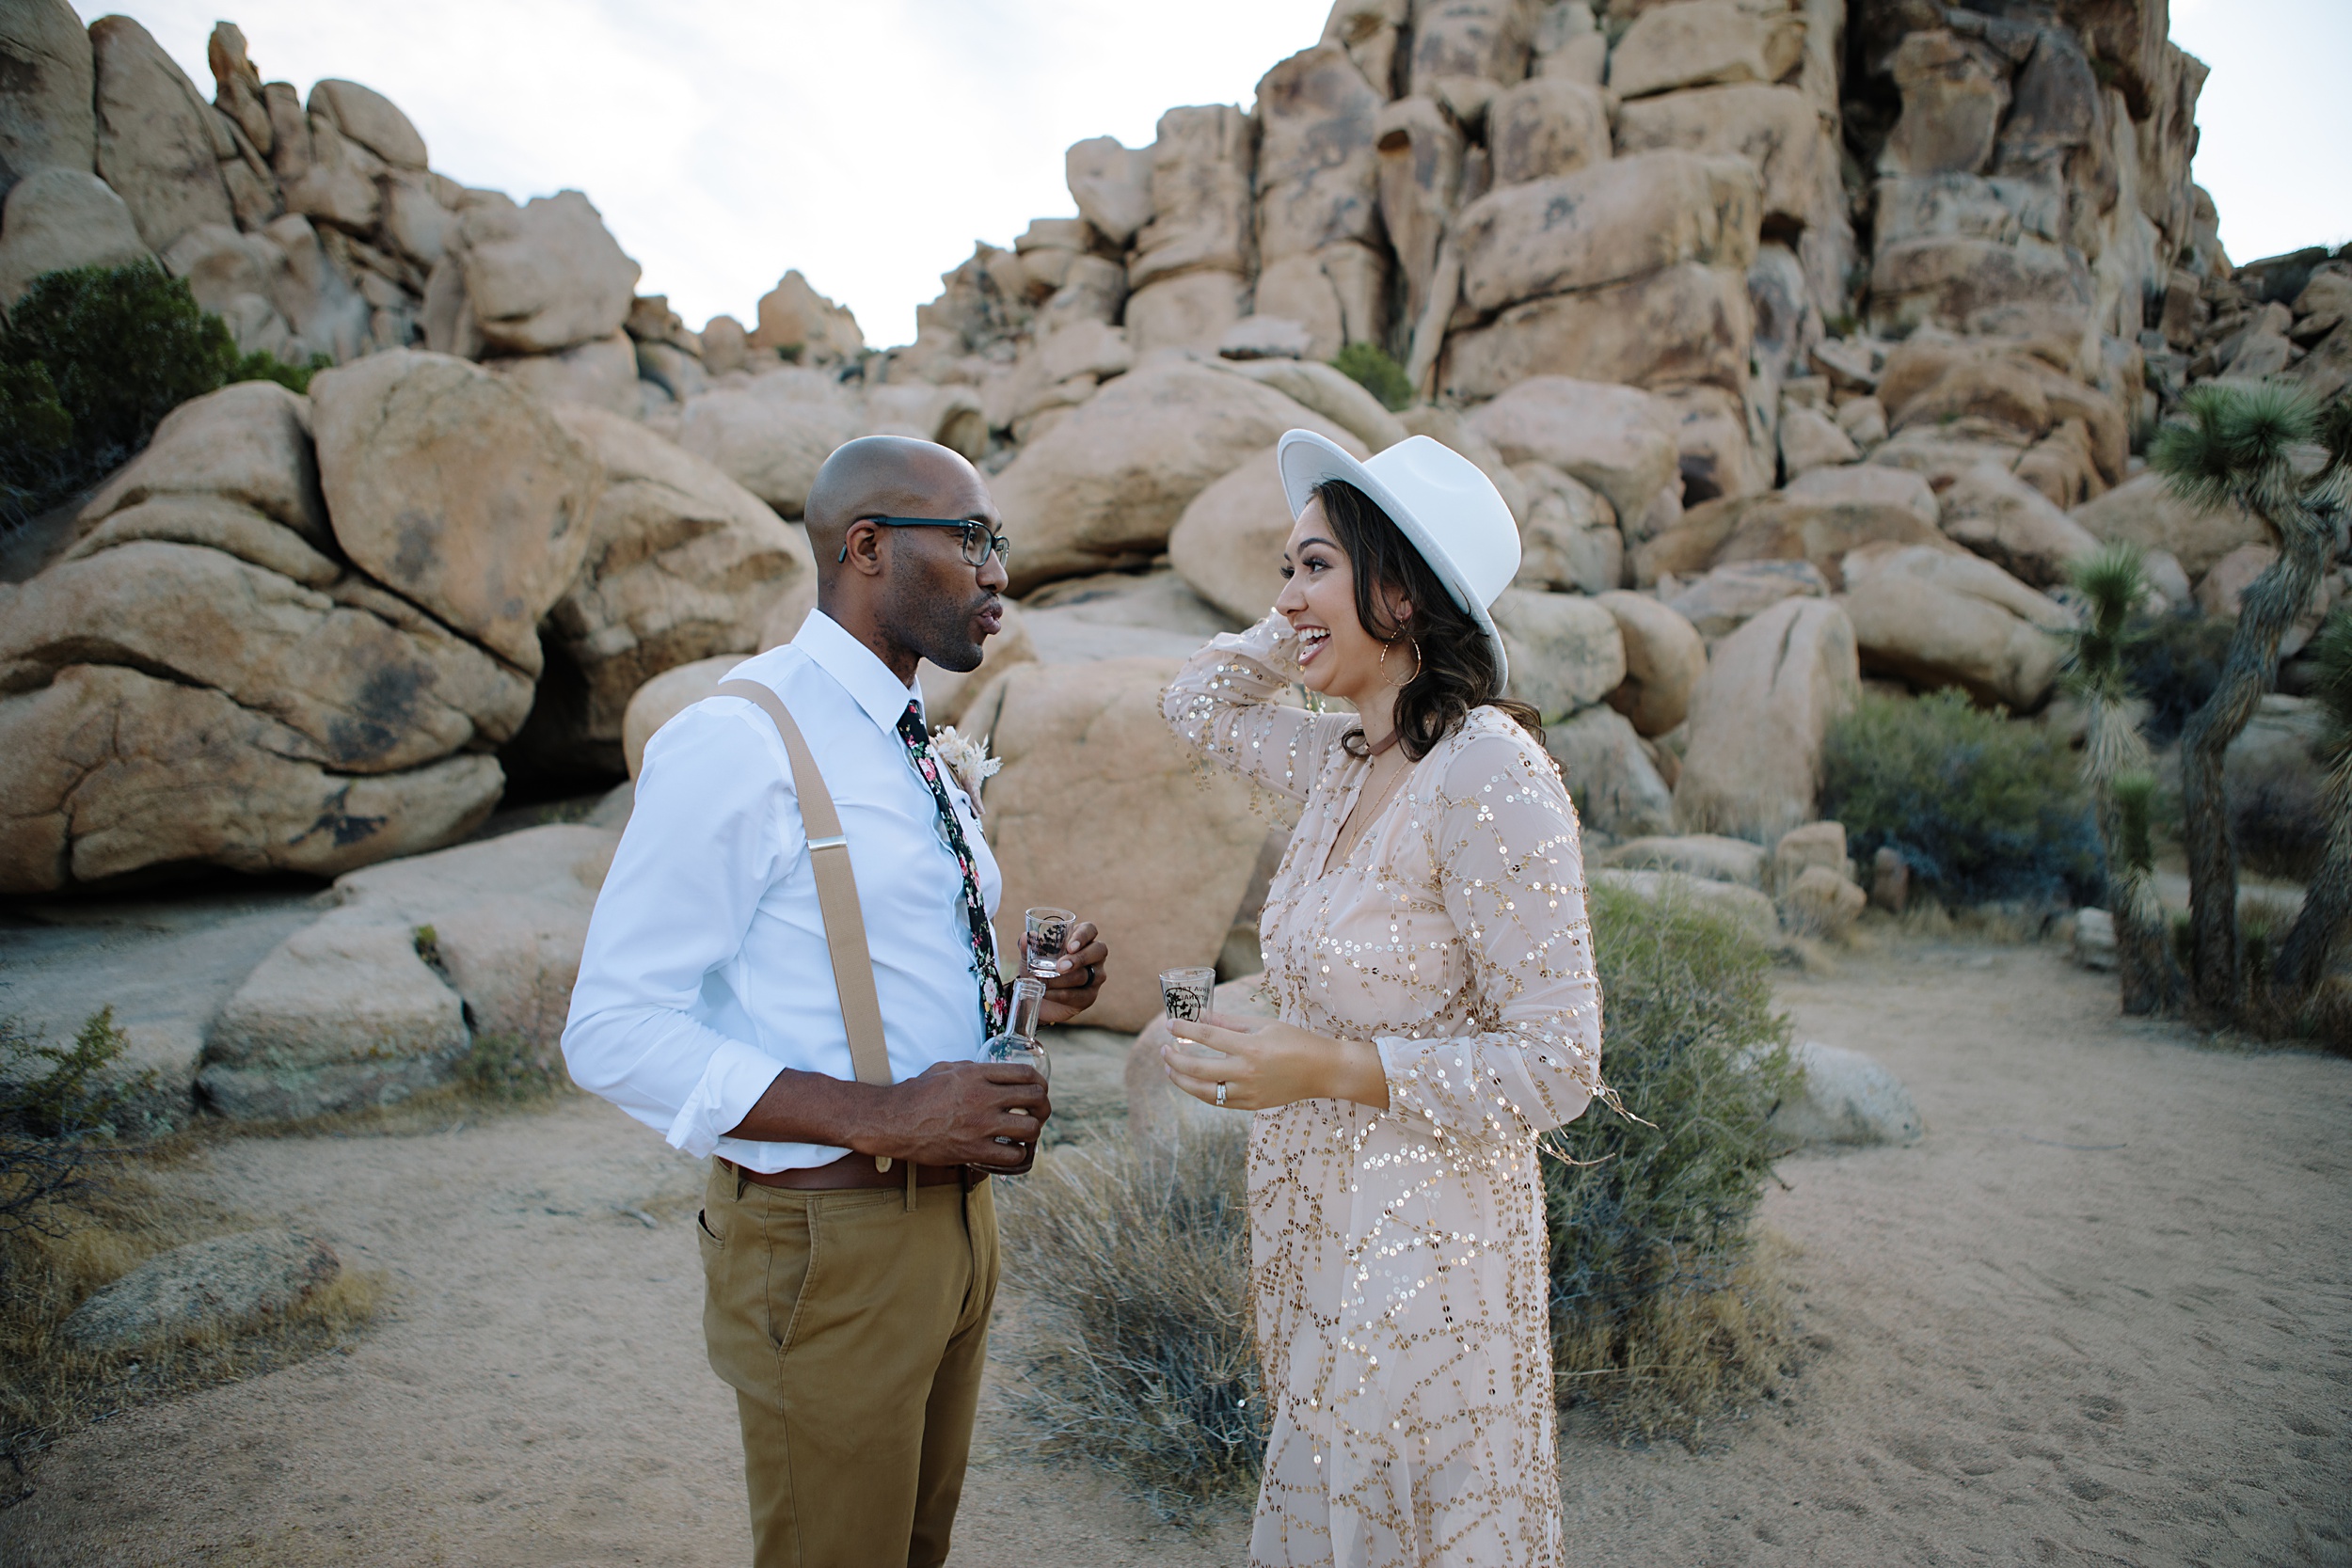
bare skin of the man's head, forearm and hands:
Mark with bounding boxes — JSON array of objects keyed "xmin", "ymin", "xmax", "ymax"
[{"xmin": 727, "ymin": 435, "xmax": 1108, "ymax": 1176}]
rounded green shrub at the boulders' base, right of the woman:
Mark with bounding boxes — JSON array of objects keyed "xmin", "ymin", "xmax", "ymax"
[{"xmin": 1820, "ymin": 691, "xmax": 2101, "ymax": 903}]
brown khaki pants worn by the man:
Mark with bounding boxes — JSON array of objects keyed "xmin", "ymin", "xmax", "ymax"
[{"xmin": 701, "ymin": 1162, "xmax": 997, "ymax": 1568}]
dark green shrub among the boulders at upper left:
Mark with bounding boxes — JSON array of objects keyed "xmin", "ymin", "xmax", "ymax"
[{"xmin": 0, "ymin": 263, "xmax": 329, "ymax": 524}]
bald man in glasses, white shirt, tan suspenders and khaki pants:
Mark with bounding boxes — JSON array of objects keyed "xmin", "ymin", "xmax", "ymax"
[{"xmin": 564, "ymin": 435, "xmax": 1105, "ymax": 1568}]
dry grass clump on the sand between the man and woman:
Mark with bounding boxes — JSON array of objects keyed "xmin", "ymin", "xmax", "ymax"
[{"xmin": 1000, "ymin": 1129, "xmax": 1265, "ymax": 1516}]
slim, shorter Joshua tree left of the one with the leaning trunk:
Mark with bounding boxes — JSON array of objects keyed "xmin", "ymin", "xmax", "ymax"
[{"xmin": 2068, "ymin": 543, "xmax": 2181, "ymax": 1013}]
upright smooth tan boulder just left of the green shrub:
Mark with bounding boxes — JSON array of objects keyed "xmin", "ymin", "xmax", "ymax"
[{"xmin": 1675, "ymin": 599, "xmax": 1861, "ymax": 842}]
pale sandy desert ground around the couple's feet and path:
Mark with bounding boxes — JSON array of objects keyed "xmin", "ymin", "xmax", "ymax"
[{"xmin": 0, "ymin": 942, "xmax": 2352, "ymax": 1568}]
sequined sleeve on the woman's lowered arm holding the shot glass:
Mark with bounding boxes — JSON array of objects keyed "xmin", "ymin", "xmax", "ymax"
[{"xmin": 1378, "ymin": 734, "xmax": 1609, "ymax": 1143}]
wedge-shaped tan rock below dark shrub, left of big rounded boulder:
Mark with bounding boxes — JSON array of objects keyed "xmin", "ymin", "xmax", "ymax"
[{"xmin": 80, "ymin": 381, "xmax": 334, "ymax": 552}]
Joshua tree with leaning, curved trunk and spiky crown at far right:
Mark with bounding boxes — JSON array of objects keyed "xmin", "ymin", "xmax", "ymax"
[{"xmin": 2148, "ymin": 383, "xmax": 2352, "ymax": 1018}]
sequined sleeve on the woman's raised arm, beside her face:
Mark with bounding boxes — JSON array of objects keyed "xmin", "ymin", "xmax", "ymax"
[{"xmin": 1160, "ymin": 613, "xmax": 1353, "ymax": 801}]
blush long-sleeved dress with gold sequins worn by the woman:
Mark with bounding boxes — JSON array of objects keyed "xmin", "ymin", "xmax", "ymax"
[{"xmin": 1165, "ymin": 616, "xmax": 1607, "ymax": 1568}]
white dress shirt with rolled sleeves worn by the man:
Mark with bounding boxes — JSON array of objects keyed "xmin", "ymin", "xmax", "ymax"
[{"xmin": 564, "ymin": 611, "xmax": 1005, "ymax": 1171}]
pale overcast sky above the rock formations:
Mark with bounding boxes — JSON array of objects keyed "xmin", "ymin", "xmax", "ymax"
[{"xmin": 110, "ymin": 0, "xmax": 2352, "ymax": 345}]
